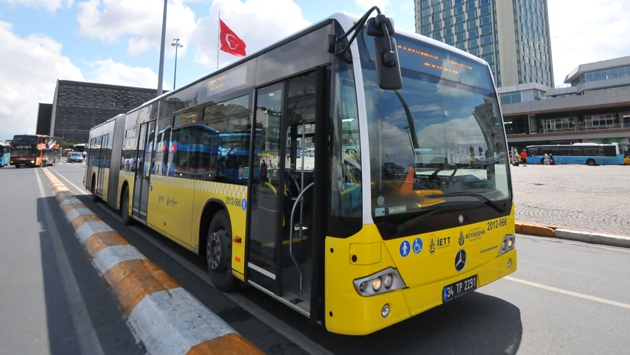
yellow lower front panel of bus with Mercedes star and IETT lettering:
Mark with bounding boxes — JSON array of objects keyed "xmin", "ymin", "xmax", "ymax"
[{"xmin": 325, "ymin": 207, "xmax": 517, "ymax": 335}]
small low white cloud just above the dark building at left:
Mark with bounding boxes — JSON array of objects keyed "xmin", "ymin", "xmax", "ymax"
[{"xmin": 86, "ymin": 58, "xmax": 160, "ymax": 88}]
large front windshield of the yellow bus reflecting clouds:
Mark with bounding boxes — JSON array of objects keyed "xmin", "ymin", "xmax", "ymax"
[{"xmin": 362, "ymin": 35, "xmax": 511, "ymax": 220}]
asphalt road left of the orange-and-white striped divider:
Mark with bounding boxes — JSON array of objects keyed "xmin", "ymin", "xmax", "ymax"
[{"xmin": 0, "ymin": 164, "xmax": 144, "ymax": 354}]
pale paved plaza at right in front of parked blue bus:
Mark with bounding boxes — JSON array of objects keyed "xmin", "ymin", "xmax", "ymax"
[{"xmin": 510, "ymin": 164, "xmax": 630, "ymax": 241}]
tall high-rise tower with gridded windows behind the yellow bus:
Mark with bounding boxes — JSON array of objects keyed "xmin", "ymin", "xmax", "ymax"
[{"xmin": 415, "ymin": 0, "xmax": 554, "ymax": 87}]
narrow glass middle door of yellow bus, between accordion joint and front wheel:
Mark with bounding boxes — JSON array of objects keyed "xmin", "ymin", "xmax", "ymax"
[{"xmin": 132, "ymin": 121, "xmax": 155, "ymax": 223}]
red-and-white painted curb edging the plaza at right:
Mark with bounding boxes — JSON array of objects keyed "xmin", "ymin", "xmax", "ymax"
[{"xmin": 516, "ymin": 221, "xmax": 630, "ymax": 248}]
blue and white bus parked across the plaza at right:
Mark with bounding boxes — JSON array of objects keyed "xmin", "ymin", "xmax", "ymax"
[{"xmin": 525, "ymin": 143, "xmax": 624, "ymax": 166}]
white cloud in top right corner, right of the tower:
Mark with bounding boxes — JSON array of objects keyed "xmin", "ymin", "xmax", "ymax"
[{"xmin": 548, "ymin": 0, "xmax": 630, "ymax": 85}]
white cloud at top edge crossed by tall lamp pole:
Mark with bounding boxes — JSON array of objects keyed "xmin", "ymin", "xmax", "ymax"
[{"xmin": 77, "ymin": 0, "xmax": 196, "ymax": 56}]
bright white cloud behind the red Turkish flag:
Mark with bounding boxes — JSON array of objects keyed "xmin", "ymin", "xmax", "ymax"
[{"xmin": 192, "ymin": 0, "xmax": 310, "ymax": 69}]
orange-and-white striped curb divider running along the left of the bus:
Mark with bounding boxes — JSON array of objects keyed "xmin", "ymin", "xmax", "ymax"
[{"xmin": 43, "ymin": 169, "xmax": 263, "ymax": 355}]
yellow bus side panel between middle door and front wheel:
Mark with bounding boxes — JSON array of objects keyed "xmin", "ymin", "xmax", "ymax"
[{"xmin": 147, "ymin": 175, "xmax": 195, "ymax": 250}]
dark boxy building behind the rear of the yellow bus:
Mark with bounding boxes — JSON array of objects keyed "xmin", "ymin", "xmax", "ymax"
[{"xmin": 46, "ymin": 80, "xmax": 157, "ymax": 143}]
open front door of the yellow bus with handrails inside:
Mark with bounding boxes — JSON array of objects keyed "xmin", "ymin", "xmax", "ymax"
[{"xmin": 247, "ymin": 71, "xmax": 323, "ymax": 316}]
